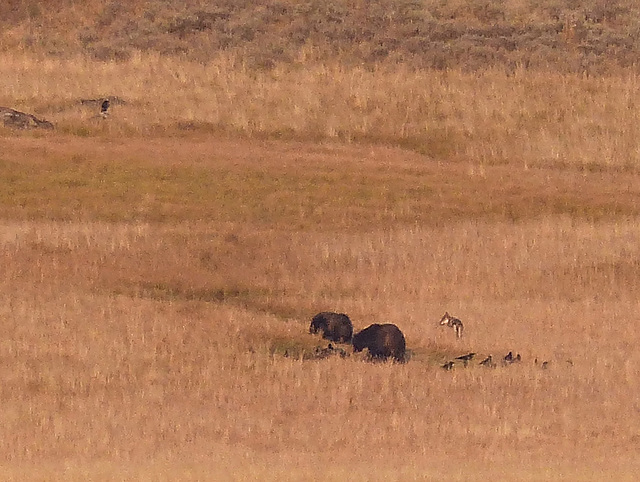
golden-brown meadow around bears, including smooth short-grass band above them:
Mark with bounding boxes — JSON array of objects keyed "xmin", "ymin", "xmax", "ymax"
[{"xmin": 0, "ymin": 135, "xmax": 640, "ymax": 480}]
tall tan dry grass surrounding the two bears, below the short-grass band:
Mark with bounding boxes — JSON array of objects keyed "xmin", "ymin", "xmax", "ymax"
[{"xmin": 2, "ymin": 218, "xmax": 640, "ymax": 480}]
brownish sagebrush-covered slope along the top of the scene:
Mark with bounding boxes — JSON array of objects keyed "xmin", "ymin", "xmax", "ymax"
[{"xmin": 0, "ymin": 0, "xmax": 640, "ymax": 74}]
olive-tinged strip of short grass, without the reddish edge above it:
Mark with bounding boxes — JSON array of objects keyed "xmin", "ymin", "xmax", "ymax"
[{"xmin": 0, "ymin": 140, "xmax": 638, "ymax": 231}]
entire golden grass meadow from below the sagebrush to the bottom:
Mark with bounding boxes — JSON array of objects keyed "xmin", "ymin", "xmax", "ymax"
[{"xmin": 0, "ymin": 0, "xmax": 640, "ymax": 481}]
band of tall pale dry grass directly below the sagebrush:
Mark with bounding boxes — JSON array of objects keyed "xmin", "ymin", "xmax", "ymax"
[{"xmin": 0, "ymin": 54, "xmax": 640, "ymax": 170}]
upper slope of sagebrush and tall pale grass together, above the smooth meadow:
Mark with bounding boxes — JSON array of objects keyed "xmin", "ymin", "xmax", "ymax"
[{"xmin": 0, "ymin": 0, "xmax": 640, "ymax": 172}]
